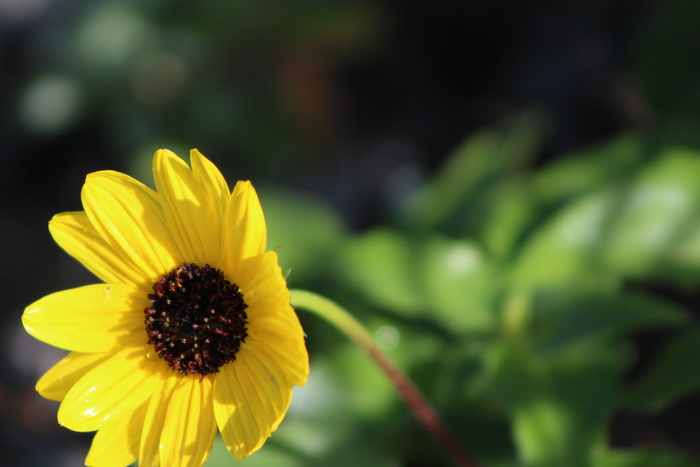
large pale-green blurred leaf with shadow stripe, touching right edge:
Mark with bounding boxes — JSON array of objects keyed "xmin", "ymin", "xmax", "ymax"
[{"xmin": 514, "ymin": 149, "xmax": 700, "ymax": 287}]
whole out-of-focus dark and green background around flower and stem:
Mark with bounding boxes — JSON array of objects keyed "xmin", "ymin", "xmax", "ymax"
[{"xmin": 0, "ymin": 0, "xmax": 700, "ymax": 467}]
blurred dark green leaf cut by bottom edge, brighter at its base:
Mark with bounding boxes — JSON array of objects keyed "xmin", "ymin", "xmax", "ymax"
[{"xmin": 484, "ymin": 339, "xmax": 626, "ymax": 467}]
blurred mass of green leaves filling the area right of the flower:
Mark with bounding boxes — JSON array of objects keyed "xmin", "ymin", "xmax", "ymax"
[{"xmin": 266, "ymin": 114, "xmax": 700, "ymax": 467}]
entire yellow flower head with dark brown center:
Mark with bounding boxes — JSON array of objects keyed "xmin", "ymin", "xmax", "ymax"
[{"xmin": 22, "ymin": 150, "xmax": 309, "ymax": 467}]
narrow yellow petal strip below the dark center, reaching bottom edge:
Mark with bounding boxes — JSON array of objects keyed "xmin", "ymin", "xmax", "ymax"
[{"xmin": 139, "ymin": 371, "xmax": 182, "ymax": 467}]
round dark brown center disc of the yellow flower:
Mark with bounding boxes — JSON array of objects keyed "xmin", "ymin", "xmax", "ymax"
[{"xmin": 144, "ymin": 263, "xmax": 248, "ymax": 377}]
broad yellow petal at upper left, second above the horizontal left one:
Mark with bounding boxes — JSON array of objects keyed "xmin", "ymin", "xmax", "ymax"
[{"xmin": 81, "ymin": 171, "xmax": 183, "ymax": 283}]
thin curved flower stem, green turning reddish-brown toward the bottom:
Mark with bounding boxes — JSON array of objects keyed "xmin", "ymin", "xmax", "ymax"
[{"xmin": 290, "ymin": 290, "xmax": 478, "ymax": 467}]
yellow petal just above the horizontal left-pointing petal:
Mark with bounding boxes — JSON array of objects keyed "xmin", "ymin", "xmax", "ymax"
[{"xmin": 49, "ymin": 211, "xmax": 150, "ymax": 286}]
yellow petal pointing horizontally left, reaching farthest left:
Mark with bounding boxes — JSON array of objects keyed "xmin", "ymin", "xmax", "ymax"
[{"xmin": 22, "ymin": 284, "xmax": 149, "ymax": 352}]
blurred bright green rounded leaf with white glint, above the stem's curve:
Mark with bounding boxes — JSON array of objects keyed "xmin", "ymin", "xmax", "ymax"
[{"xmin": 341, "ymin": 230, "xmax": 500, "ymax": 332}]
